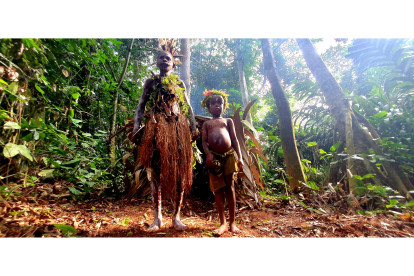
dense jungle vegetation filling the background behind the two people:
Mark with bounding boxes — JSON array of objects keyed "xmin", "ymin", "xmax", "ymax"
[{"xmin": 0, "ymin": 38, "xmax": 414, "ymax": 212}]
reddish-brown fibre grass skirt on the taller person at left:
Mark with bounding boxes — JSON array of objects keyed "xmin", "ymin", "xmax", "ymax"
[{"xmin": 137, "ymin": 113, "xmax": 193, "ymax": 199}]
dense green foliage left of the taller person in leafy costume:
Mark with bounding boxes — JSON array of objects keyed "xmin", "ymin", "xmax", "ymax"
[{"xmin": 0, "ymin": 39, "xmax": 156, "ymax": 195}]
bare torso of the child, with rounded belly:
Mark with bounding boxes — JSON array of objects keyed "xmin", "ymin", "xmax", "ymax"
[{"xmin": 205, "ymin": 118, "xmax": 232, "ymax": 153}]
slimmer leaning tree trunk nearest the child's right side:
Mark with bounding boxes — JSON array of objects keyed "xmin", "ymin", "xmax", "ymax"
[{"xmin": 261, "ymin": 39, "xmax": 306, "ymax": 193}]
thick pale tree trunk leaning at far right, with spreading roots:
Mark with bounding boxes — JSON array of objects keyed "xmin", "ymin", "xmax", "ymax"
[{"xmin": 296, "ymin": 39, "xmax": 414, "ymax": 199}]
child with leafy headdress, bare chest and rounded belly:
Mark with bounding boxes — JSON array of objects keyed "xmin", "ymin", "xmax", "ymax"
[{"xmin": 201, "ymin": 89, "xmax": 244, "ymax": 236}]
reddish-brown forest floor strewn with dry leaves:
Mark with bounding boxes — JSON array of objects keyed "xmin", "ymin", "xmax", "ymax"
[{"xmin": 0, "ymin": 184, "xmax": 414, "ymax": 238}]
